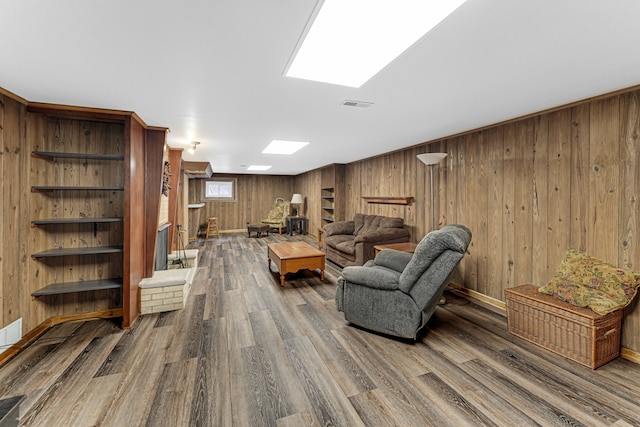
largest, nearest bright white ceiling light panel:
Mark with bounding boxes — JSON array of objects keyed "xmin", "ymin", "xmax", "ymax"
[{"xmin": 285, "ymin": 0, "xmax": 465, "ymax": 88}]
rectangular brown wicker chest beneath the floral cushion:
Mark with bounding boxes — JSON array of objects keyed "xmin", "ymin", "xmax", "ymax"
[{"xmin": 505, "ymin": 285, "xmax": 622, "ymax": 369}]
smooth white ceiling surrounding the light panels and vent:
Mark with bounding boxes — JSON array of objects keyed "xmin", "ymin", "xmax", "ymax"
[{"xmin": 0, "ymin": 0, "xmax": 640, "ymax": 174}]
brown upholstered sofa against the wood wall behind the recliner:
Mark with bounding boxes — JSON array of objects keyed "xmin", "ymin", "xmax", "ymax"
[{"xmin": 322, "ymin": 213, "xmax": 409, "ymax": 267}]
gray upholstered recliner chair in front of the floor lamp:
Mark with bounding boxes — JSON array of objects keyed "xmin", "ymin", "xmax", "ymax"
[{"xmin": 335, "ymin": 224, "xmax": 471, "ymax": 339}]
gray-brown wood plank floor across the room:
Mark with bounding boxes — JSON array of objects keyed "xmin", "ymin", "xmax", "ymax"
[{"xmin": 0, "ymin": 234, "xmax": 640, "ymax": 427}]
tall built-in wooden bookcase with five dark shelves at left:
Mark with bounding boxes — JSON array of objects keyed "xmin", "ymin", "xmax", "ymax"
[{"xmin": 27, "ymin": 104, "xmax": 166, "ymax": 328}]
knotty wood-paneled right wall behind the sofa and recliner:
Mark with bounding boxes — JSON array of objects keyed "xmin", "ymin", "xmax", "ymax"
[{"xmin": 296, "ymin": 85, "xmax": 640, "ymax": 351}]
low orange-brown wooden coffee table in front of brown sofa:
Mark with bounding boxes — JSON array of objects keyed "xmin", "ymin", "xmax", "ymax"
[{"xmin": 267, "ymin": 242, "xmax": 325, "ymax": 286}]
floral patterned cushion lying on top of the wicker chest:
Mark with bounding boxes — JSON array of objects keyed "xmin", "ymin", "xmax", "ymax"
[{"xmin": 539, "ymin": 248, "xmax": 640, "ymax": 314}]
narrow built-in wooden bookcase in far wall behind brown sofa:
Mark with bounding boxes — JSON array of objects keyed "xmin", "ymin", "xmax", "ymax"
[{"xmin": 320, "ymin": 163, "xmax": 345, "ymax": 226}]
